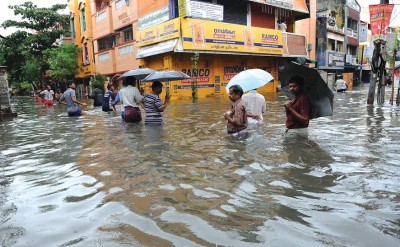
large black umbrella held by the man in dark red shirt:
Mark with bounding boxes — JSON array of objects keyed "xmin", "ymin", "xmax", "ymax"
[{"xmin": 278, "ymin": 62, "xmax": 334, "ymax": 119}]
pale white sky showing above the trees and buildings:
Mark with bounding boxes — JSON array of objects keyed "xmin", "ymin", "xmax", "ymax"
[{"xmin": 0, "ymin": 0, "xmax": 400, "ymax": 36}]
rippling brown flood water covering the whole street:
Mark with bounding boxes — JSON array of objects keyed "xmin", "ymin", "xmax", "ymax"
[{"xmin": 0, "ymin": 85, "xmax": 400, "ymax": 247}]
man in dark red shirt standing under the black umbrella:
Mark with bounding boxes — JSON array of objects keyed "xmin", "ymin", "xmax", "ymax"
[{"xmin": 285, "ymin": 76, "xmax": 311, "ymax": 137}]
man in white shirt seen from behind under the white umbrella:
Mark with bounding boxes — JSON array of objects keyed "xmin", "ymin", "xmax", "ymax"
[{"xmin": 242, "ymin": 89, "xmax": 266, "ymax": 124}]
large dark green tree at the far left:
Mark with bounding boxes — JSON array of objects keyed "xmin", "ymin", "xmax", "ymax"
[{"xmin": 0, "ymin": 2, "xmax": 68, "ymax": 89}]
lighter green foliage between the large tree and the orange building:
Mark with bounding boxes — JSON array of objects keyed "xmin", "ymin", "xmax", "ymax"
[{"xmin": 44, "ymin": 44, "xmax": 81, "ymax": 81}]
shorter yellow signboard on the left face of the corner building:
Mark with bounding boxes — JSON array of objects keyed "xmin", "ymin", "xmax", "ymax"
[{"xmin": 136, "ymin": 18, "xmax": 180, "ymax": 47}]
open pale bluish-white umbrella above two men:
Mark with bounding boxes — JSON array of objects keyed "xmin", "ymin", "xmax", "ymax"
[{"xmin": 226, "ymin": 69, "xmax": 274, "ymax": 93}]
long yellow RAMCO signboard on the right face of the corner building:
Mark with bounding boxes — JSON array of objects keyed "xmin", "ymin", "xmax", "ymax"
[{"xmin": 182, "ymin": 18, "xmax": 283, "ymax": 55}]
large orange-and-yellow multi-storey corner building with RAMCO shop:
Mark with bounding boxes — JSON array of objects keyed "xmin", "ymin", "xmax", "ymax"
[{"xmin": 71, "ymin": 0, "xmax": 315, "ymax": 97}]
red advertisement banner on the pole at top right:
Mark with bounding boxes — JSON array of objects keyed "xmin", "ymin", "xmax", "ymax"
[{"xmin": 369, "ymin": 4, "xmax": 394, "ymax": 41}]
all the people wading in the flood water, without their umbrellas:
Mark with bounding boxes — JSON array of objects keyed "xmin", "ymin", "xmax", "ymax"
[{"xmin": 35, "ymin": 76, "xmax": 311, "ymax": 137}]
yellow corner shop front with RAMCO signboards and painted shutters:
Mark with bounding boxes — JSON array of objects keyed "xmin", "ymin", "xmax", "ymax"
[{"xmin": 137, "ymin": 18, "xmax": 283, "ymax": 98}]
